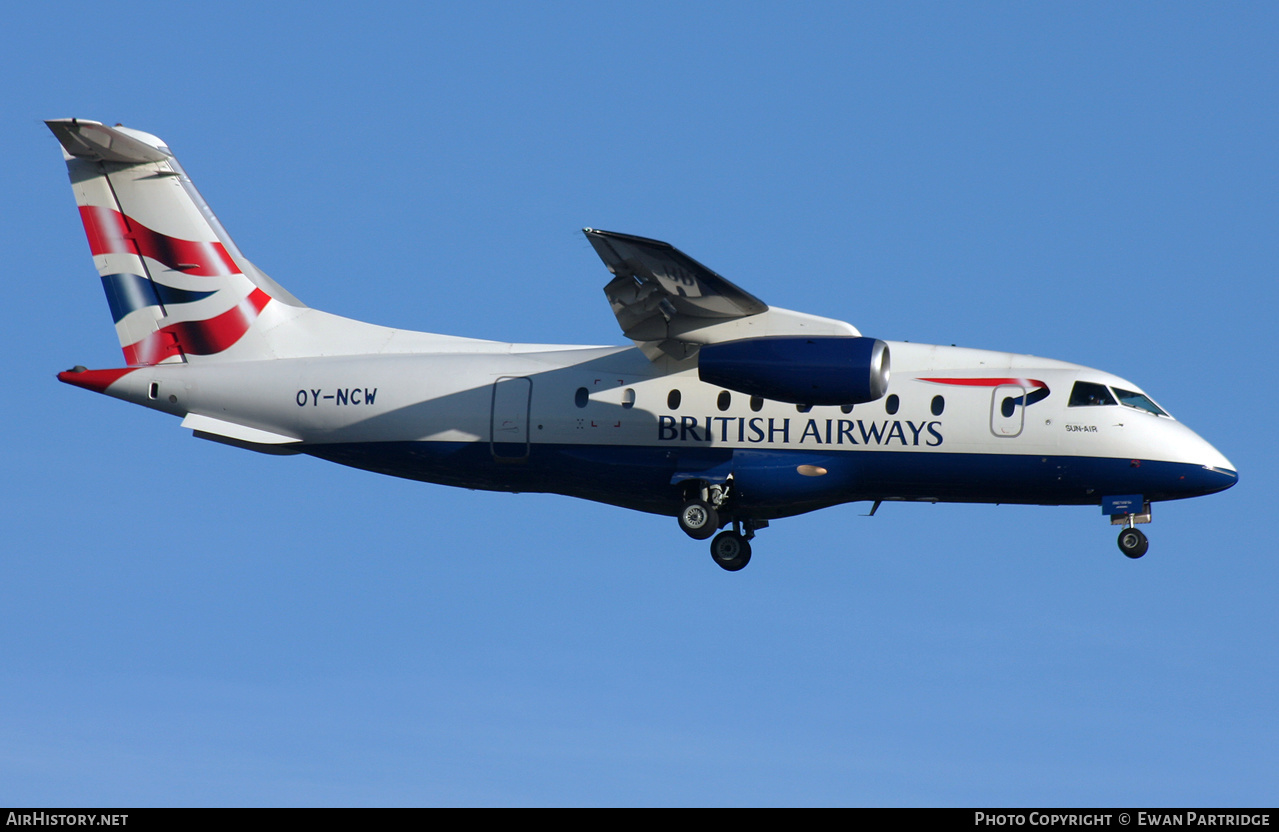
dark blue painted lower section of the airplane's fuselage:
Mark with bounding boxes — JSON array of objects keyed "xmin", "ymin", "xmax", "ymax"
[{"xmin": 304, "ymin": 442, "xmax": 1236, "ymax": 519}]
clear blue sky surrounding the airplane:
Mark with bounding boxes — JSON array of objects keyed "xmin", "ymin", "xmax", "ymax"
[{"xmin": 0, "ymin": 3, "xmax": 1279, "ymax": 806}]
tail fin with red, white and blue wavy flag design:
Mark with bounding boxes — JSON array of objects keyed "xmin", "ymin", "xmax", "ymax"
[{"xmin": 46, "ymin": 119, "xmax": 304, "ymax": 366}]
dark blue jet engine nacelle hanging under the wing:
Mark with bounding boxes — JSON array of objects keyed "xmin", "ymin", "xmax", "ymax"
[{"xmin": 697, "ymin": 335, "xmax": 889, "ymax": 405}]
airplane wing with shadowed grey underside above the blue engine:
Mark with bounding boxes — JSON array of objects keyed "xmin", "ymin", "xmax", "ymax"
[{"xmin": 582, "ymin": 229, "xmax": 859, "ymax": 359}]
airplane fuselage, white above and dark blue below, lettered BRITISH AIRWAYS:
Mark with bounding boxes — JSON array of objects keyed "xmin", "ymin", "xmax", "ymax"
[{"xmin": 82, "ymin": 341, "xmax": 1234, "ymax": 518}]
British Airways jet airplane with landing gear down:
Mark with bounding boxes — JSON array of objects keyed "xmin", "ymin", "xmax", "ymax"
[{"xmin": 46, "ymin": 119, "xmax": 1238, "ymax": 571}]
